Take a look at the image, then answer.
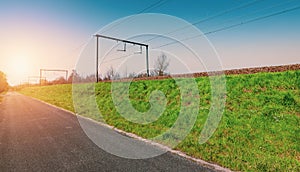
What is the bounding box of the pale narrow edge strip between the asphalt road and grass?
[15,92,231,172]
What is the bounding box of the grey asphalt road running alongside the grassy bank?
[0,92,211,172]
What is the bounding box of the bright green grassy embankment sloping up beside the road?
[20,70,300,171]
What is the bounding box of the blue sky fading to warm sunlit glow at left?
[0,0,300,85]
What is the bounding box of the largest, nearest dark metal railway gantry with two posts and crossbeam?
[94,34,150,82]
